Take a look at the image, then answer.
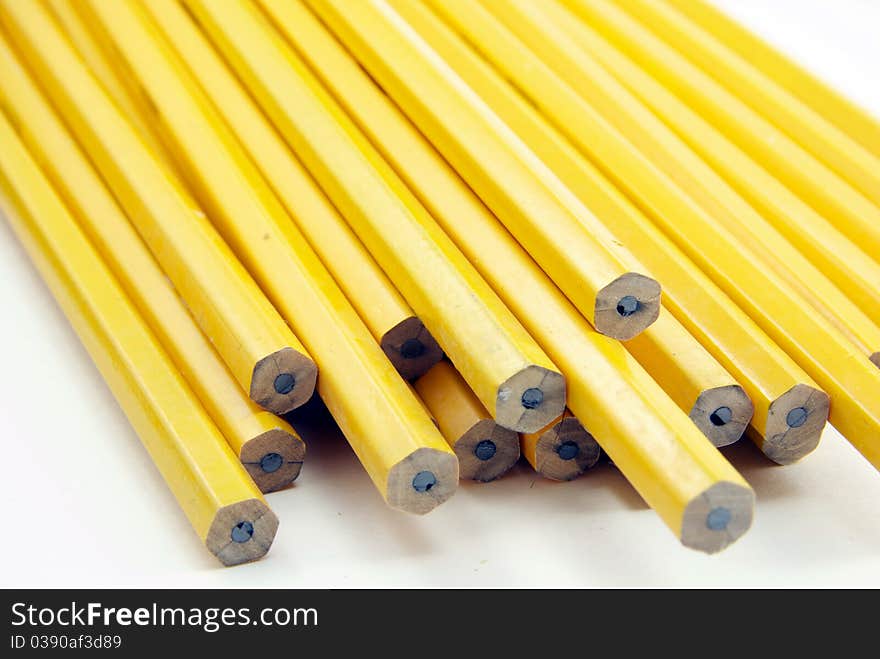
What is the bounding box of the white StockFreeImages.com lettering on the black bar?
[12,602,318,633]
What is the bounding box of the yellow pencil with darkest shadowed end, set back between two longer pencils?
[142,0,443,380]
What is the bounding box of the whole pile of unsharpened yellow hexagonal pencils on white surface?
[0,0,880,565]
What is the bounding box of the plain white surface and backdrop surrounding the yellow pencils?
[0,0,880,587]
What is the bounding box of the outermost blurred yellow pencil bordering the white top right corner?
[671,0,880,158]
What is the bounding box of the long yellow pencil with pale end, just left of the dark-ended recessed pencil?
[62,1,458,514]
